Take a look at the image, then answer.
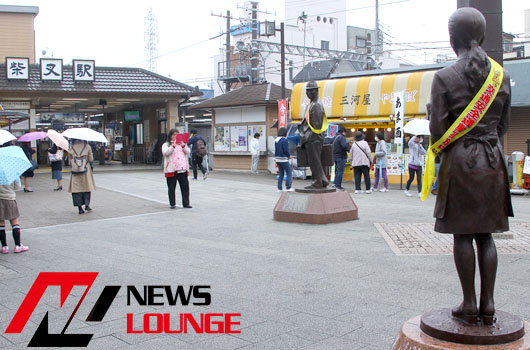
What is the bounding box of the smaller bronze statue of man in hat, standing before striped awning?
[298,81,329,189]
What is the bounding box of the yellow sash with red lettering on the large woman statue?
[421,57,504,201]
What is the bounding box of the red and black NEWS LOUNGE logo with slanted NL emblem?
[5,272,241,347]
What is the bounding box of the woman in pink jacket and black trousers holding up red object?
[162,129,191,209]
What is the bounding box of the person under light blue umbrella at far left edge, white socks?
[0,142,31,254]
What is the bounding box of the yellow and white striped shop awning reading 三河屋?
[291,70,436,120]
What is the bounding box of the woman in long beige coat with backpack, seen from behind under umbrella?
[68,140,96,214]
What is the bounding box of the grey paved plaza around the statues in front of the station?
[0,169,530,350]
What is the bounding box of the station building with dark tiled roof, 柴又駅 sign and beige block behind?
[0,5,201,163]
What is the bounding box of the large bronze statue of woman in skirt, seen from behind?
[430,7,513,325]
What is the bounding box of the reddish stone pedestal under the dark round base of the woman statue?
[391,316,530,350]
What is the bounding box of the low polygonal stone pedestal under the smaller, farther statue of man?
[274,189,359,224]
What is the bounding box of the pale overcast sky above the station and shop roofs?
[2,0,530,88]
